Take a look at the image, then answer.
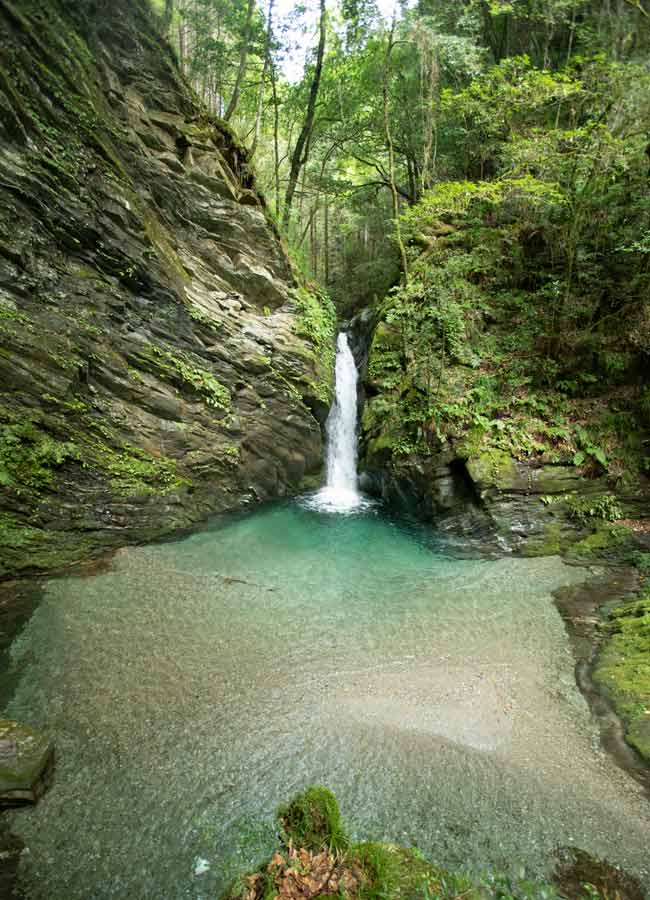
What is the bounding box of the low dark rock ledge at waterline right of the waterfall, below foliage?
[361,450,650,561]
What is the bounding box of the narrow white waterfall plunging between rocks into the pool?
[312,331,362,511]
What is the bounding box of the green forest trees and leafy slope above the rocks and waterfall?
[153,0,650,477]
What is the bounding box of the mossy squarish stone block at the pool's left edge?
[0,719,54,806]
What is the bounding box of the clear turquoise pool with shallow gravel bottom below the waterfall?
[7,503,650,900]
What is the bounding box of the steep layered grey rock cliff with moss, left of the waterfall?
[0,0,333,576]
